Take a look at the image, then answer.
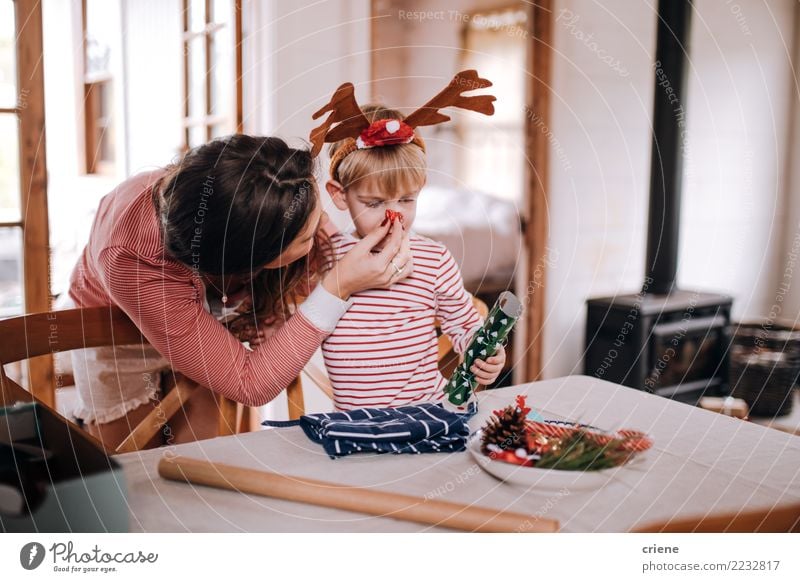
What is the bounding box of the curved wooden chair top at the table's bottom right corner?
[634,504,800,533]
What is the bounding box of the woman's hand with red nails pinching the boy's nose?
[322,222,414,300]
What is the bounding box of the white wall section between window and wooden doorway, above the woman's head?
[244,0,370,143]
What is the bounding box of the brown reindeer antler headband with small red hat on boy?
[310,69,496,178]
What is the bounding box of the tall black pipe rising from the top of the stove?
[642,0,692,295]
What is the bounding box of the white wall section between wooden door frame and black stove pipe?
[543,0,656,377]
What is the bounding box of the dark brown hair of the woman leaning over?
[153,134,324,315]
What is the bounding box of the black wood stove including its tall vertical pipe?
[584,0,733,404]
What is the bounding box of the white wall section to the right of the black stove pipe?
[679,0,796,318]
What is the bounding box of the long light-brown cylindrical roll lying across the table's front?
[158,457,558,532]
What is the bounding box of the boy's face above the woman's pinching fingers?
[327,181,421,237]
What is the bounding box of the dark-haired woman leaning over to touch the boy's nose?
[69,135,413,447]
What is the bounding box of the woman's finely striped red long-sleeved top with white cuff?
[69,170,350,406]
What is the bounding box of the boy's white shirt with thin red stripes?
[322,233,481,410]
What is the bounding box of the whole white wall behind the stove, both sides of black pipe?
[544,0,794,377]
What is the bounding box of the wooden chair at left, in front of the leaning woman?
[0,307,238,454]
